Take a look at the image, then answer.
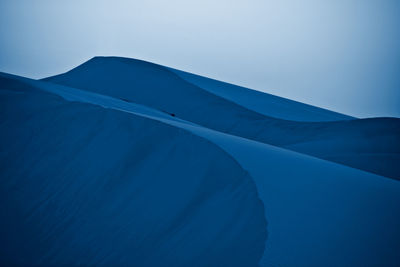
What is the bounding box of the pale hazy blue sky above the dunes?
[0,0,400,117]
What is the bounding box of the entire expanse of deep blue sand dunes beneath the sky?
[0,57,400,266]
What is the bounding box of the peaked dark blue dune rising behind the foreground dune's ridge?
[45,57,400,179]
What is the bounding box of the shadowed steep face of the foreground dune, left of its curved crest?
[0,78,267,266]
